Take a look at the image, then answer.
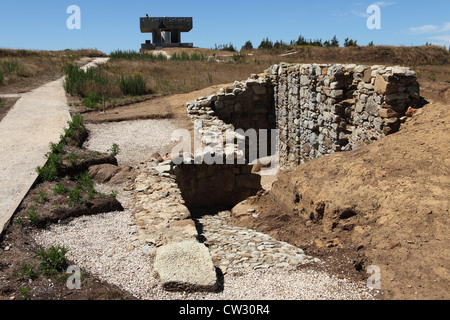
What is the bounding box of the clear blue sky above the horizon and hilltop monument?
[0,0,450,53]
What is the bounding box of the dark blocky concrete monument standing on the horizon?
[140,14,194,51]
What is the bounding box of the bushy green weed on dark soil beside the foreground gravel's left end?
[35,245,69,275]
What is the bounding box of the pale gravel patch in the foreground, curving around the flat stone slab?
[35,185,373,300]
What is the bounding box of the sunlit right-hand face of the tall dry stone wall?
[267,64,420,165]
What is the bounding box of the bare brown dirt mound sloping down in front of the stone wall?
[234,91,450,299]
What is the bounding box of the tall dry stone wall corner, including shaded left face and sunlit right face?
[187,63,420,166]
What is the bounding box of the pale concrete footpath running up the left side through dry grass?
[0,58,107,234]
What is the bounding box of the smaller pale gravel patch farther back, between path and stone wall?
[84,119,179,166]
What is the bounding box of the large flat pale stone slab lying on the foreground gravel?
[153,240,218,292]
